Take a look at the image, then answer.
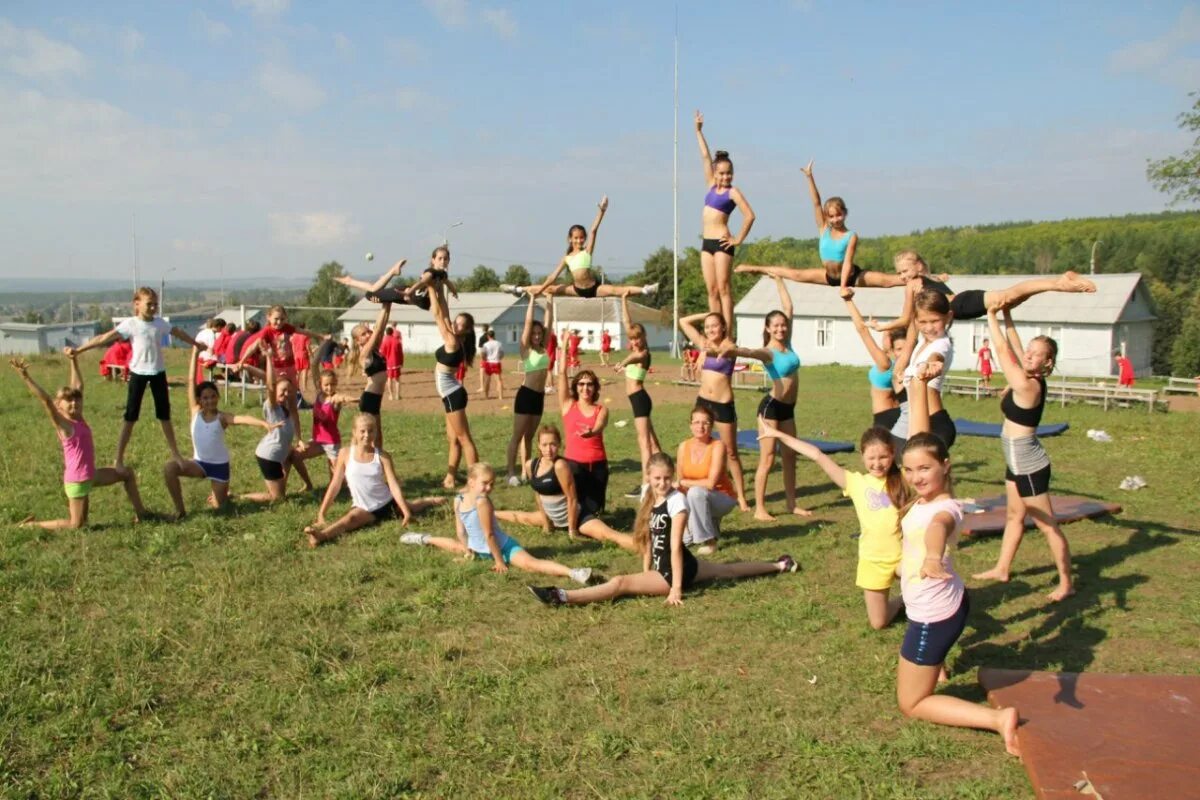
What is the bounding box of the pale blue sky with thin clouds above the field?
[0,0,1200,287]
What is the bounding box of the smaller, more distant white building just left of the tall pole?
[337,291,671,354]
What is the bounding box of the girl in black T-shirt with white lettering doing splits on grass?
[529,452,798,606]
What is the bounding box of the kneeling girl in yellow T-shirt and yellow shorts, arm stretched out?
[758,422,908,631]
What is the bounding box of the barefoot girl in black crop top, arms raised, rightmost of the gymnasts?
[974,311,1075,601]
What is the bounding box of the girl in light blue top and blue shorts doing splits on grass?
[400,462,592,585]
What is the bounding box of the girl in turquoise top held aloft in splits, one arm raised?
[737,161,905,297]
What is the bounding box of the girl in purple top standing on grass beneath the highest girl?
[679,312,750,511]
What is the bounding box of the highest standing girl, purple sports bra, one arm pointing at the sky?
[696,110,754,328]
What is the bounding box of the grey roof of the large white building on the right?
[733,272,1154,325]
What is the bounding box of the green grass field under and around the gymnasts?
[0,353,1200,798]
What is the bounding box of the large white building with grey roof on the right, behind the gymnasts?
[733,272,1156,378]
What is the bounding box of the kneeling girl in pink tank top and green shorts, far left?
[8,353,146,530]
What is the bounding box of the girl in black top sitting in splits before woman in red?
[496,425,636,552]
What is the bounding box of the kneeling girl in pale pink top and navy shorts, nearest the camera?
[896,362,1020,756]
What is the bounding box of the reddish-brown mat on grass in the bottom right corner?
[979,667,1200,800]
